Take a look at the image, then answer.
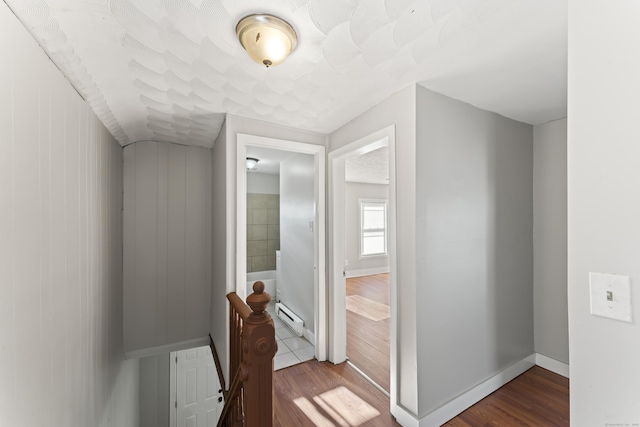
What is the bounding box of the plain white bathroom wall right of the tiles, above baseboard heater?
[277,154,315,333]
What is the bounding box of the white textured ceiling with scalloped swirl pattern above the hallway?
[6,0,567,147]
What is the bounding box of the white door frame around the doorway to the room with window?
[328,125,398,408]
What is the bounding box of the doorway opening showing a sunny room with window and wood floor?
[343,145,391,394]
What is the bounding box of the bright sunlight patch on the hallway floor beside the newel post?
[294,386,380,427]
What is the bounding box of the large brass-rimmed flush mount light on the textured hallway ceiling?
[236,14,298,68]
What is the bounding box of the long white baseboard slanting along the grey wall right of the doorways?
[420,354,536,427]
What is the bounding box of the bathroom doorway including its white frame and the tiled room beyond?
[236,134,326,369]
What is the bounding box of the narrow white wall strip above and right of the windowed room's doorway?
[329,85,418,416]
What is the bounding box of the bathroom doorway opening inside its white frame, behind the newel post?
[246,145,315,370]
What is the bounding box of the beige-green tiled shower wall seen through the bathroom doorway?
[247,193,280,273]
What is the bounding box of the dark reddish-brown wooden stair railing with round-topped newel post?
[210,282,278,427]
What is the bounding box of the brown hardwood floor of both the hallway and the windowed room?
[274,274,569,427]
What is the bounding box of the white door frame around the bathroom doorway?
[236,133,327,361]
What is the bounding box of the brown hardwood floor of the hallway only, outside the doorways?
[274,360,569,427]
